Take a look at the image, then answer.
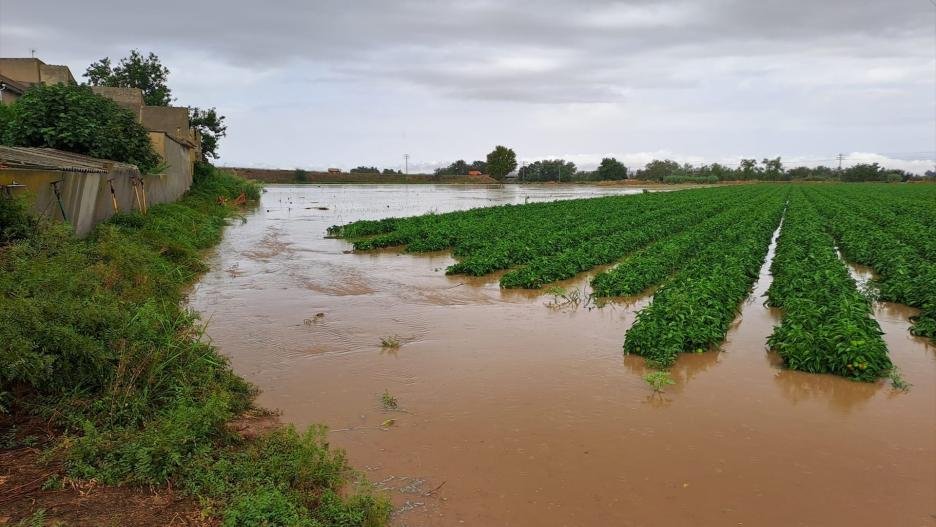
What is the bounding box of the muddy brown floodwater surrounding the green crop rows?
[191,186,936,526]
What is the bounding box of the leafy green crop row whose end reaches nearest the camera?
[767,189,891,381]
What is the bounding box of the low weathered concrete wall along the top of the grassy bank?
[0,161,192,237]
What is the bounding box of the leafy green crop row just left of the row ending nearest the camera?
[624,192,785,367]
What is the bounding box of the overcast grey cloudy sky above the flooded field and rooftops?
[0,0,936,172]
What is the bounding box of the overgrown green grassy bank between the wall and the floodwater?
[0,165,389,526]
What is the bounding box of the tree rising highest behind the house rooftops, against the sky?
[84,49,172,106]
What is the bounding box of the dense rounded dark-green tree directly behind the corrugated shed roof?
[4,84,160,173]
